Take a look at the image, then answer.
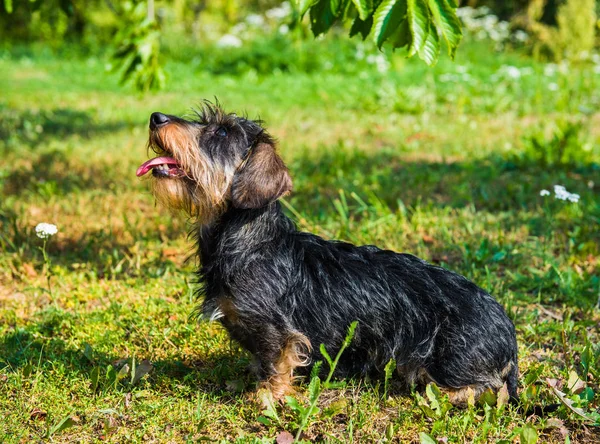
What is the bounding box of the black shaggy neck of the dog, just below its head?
[196,202,296,266]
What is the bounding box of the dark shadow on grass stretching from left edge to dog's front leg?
[0,307,254,396]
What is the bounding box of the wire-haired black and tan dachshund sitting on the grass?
[137,103,518,404]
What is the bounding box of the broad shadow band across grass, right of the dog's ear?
[290,149,598,219]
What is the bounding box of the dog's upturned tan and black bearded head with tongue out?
[137,102,292,223]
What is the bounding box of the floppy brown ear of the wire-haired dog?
[231,141,292,209]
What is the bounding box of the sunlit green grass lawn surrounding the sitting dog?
[0,35,600,443]
